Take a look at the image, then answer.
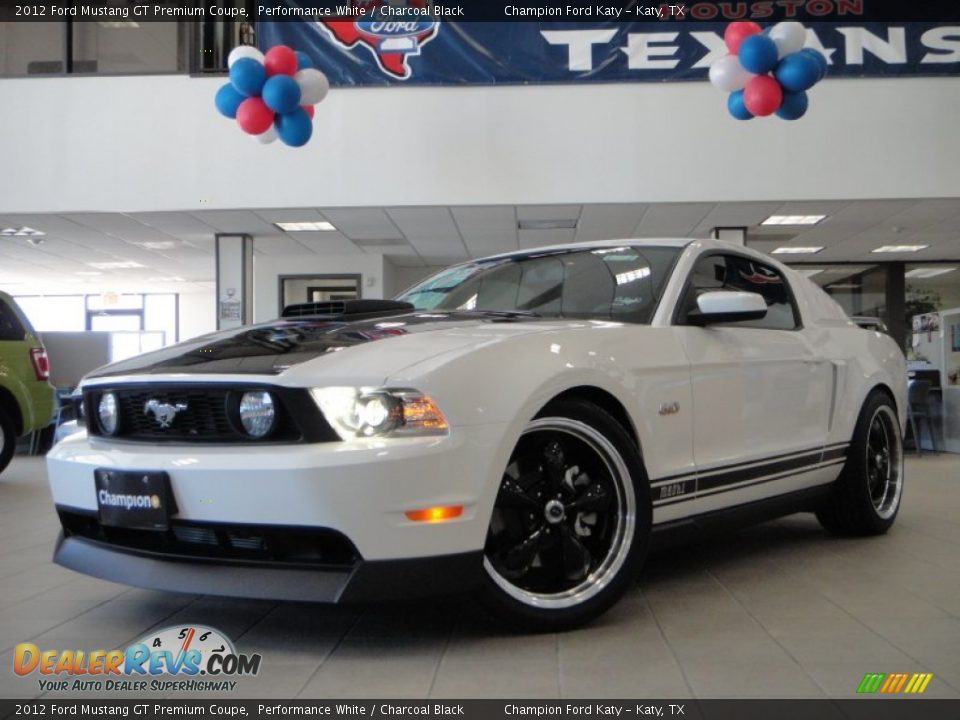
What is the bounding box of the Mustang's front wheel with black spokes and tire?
[479,401,653,632]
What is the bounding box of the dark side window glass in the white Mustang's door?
[684,255,799,330]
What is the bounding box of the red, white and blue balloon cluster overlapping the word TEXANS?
[710,21,827,120]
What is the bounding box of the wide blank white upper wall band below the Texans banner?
[0,76,960,215]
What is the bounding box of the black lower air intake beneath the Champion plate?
[59,510,361,567]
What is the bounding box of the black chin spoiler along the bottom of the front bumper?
[53,533,483,603]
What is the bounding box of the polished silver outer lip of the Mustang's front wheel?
[483,417,637,610]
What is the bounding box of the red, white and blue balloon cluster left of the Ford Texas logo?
[214,45,330,147]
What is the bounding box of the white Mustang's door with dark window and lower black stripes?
[674,251,833,513]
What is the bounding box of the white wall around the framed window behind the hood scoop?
[253,255,386,322]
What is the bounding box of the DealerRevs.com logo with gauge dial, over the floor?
[13,625,262,692]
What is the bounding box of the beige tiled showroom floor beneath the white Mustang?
[0,455,960,698]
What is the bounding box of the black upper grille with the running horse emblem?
[84,383,339,443]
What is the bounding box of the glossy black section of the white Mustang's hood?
[87,312,556,379]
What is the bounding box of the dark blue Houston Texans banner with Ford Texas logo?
[258,18,960,86]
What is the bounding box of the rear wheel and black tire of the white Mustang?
[817,391,903,537]
